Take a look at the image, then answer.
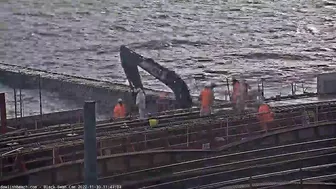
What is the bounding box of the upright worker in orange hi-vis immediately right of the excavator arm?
[200,83,215,116]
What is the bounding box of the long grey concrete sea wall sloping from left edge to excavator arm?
[0,64,202,115]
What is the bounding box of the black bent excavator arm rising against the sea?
[120,45,192,108]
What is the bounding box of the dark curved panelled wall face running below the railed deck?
[0,122,336,185]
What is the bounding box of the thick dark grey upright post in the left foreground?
[84,101,97,186]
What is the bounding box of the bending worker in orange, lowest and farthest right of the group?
[258,102,274,133]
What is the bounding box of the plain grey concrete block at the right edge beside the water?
[317,73,336,95]
